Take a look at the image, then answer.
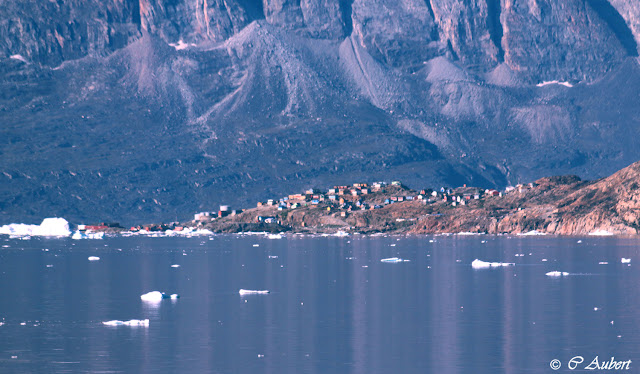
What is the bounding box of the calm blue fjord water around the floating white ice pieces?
[0,235,640,373]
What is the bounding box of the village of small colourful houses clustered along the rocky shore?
[78,181,536,233]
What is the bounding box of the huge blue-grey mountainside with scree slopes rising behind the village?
[0,0,640,223]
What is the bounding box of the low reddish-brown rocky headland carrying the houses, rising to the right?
[166,162,640,235]
